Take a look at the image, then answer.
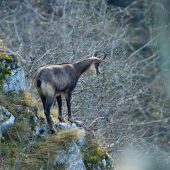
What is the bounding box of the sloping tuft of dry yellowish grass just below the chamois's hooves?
[19,129,83,170]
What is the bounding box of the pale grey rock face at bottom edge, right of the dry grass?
[53,141,86,170]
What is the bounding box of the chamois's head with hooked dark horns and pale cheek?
[88,51,106,75]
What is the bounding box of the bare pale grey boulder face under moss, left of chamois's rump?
[3,68,25,93]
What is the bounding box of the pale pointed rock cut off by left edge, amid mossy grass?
[0,106,15,137]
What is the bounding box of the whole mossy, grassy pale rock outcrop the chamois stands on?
[0,48,111,170]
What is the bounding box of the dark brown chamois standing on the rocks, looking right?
[34,51,106,133]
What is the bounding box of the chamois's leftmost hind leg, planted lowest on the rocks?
[44,96,55,133]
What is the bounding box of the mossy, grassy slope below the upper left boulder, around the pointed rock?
[0,91,37,169]
